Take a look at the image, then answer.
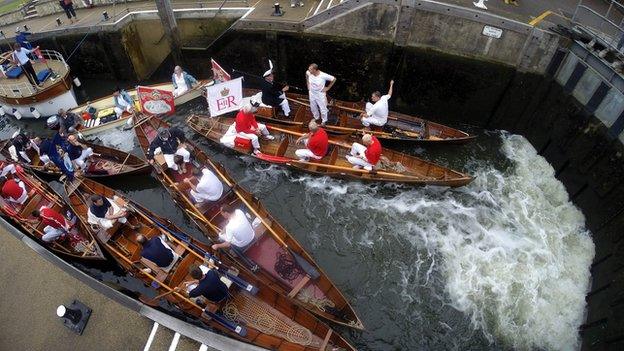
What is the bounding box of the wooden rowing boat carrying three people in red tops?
[187,115,472,187]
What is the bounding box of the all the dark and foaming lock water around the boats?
[0,97,594,350]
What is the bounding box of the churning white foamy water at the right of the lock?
[290,134,594,350]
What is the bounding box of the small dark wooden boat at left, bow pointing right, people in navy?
[0,140,150,178]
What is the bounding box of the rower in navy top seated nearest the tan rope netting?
[175,260,228,303]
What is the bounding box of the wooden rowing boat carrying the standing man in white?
[244,89,476,144]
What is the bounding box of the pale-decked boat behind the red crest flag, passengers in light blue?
[70,80,213,136]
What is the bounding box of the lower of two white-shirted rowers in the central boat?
[212,205,255,250]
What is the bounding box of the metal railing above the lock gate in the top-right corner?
[572,0,624,53]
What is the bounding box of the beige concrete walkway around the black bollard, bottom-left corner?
[0,227,205,351]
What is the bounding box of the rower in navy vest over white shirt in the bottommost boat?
[87,194,138,229]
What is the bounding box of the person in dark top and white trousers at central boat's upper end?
[147,127,191,171]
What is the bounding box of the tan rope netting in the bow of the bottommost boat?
[222,293,320,347]
